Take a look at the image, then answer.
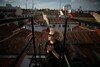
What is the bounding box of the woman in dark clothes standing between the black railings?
[45,28,62,67]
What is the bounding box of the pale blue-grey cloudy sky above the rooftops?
[0,0,100,10]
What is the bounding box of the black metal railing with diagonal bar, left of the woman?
[0,17,36,67]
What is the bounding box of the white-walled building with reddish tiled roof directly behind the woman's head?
[43,10,77,31]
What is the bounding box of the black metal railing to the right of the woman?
[63,18,100,67]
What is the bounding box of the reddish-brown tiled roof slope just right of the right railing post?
[66,30,100,44]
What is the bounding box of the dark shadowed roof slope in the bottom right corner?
[75,45,100,64]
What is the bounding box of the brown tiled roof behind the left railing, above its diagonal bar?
[0,29,31,55]
